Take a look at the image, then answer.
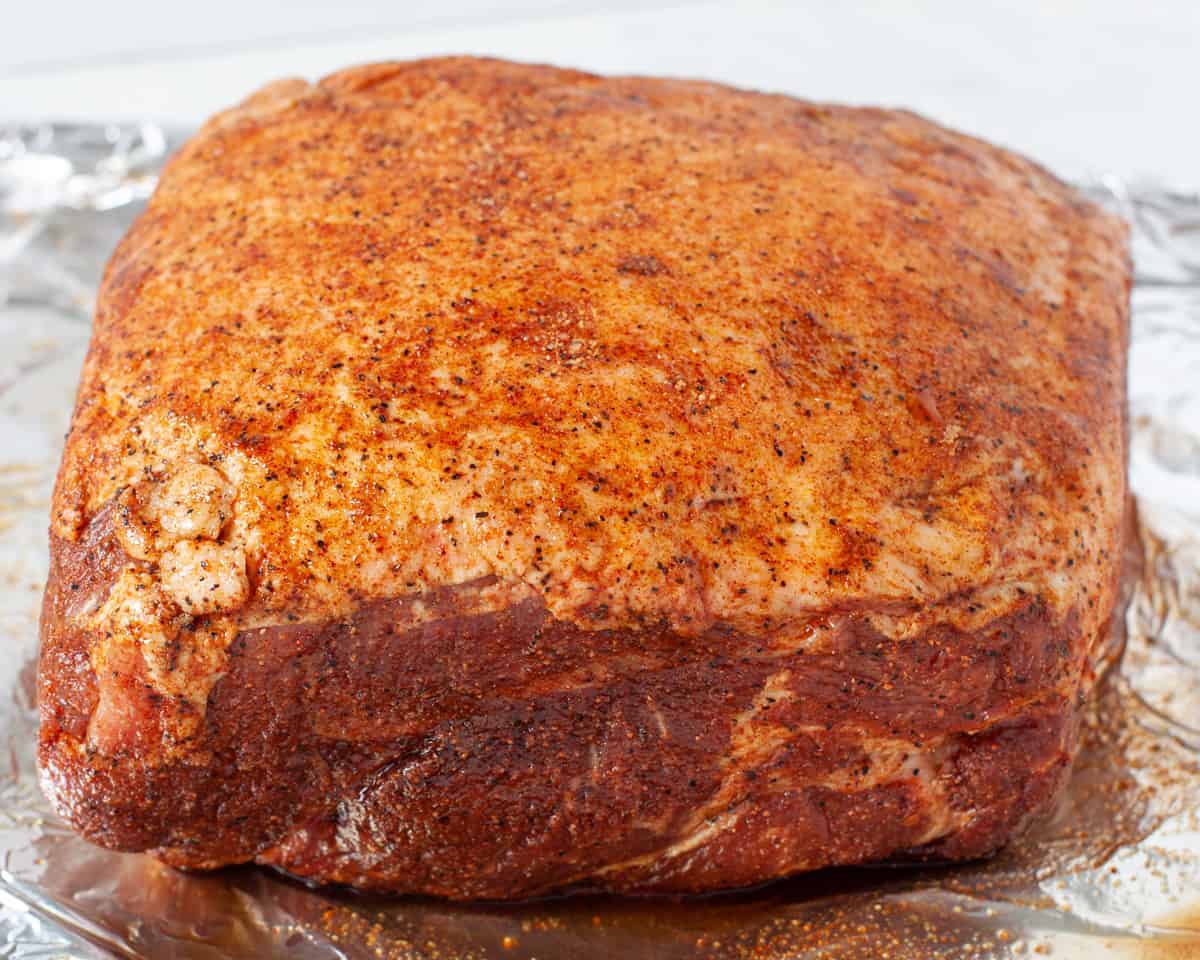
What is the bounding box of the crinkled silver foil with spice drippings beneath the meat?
[0,126,1200,960]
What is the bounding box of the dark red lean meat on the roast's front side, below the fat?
[40,501,1091,898]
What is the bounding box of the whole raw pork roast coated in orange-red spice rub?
[32,59,1130,898]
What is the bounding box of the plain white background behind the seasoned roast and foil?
[0,0,1200,187]
